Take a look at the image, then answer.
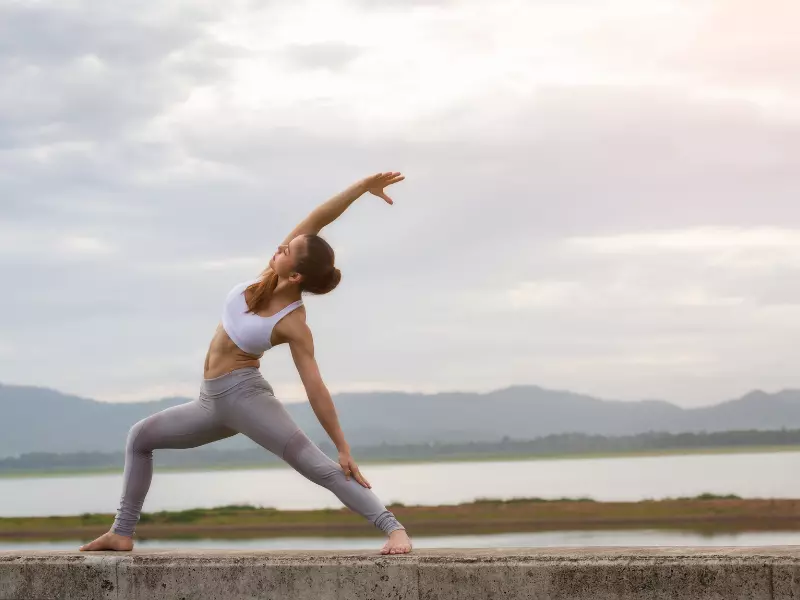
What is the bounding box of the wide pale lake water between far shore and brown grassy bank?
[0,452,800,516]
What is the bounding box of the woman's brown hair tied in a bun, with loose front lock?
[247,234,342,313]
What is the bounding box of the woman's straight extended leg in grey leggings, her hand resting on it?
[220,379,404,534]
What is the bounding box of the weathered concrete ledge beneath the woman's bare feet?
[0,546,800,600]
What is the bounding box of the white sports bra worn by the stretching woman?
[222,279,303,355]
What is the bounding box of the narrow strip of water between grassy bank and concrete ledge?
[0,530,800,551]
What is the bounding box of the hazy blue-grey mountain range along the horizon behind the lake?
[0,384,800,458]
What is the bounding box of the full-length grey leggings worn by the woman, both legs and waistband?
[111,367,404,536]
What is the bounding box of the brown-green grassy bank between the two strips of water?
[0,495,800,540]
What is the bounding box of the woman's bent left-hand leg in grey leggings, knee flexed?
[111,398,236,536]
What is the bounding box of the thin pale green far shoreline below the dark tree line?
[0,445,800,479]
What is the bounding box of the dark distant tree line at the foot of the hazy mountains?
[0,429,800,473]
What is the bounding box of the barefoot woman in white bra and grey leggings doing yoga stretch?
[80,173,411,554]
